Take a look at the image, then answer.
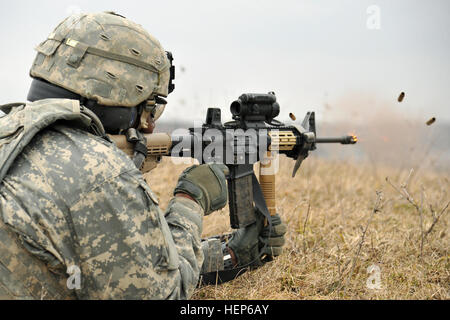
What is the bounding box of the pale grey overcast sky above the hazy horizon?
[0,0,450,121]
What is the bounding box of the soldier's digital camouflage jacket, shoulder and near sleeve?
[0,100,204,299]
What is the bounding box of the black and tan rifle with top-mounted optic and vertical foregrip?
[111,92,357,229]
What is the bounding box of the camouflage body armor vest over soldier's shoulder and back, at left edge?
[0,99,105,300]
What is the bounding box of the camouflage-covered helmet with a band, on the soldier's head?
[30,13,170,107]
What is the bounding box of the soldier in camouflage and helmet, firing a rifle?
[0,12,286,299]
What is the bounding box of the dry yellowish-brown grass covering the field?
[149,157,450,300]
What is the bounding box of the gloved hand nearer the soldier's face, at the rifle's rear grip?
[174,164,229,215]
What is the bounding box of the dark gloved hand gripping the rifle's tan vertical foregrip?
[228,214,287,267]
